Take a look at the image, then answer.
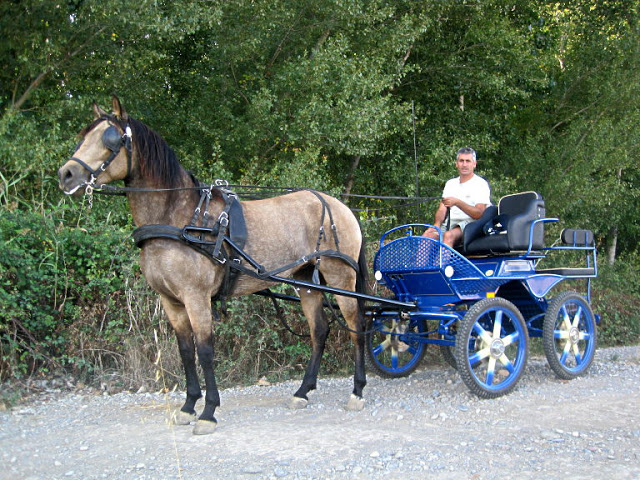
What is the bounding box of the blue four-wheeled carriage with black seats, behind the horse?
[367,192,599,398]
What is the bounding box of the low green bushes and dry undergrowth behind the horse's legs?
[0,210,351,388]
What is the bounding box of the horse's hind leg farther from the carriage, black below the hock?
[290,290,329,409]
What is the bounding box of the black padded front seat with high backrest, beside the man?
[463,192,545,255]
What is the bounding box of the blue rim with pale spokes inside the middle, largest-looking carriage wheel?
[468,307,527,393]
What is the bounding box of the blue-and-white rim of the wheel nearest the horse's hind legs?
[369,318,425,373]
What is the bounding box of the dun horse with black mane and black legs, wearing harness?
[58,96,366,435]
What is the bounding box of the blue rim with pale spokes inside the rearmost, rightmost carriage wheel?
[553,298,595,373]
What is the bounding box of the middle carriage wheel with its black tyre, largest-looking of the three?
[455,297,529,398]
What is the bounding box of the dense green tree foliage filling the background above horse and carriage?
[0,0,640,384]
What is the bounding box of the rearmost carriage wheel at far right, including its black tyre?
[542,292,597,380]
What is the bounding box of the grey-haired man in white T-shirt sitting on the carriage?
[423,147,491,247]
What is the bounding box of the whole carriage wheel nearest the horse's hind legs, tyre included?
[365,316,427,378]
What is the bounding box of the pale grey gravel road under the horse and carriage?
[0,347,640,480]
